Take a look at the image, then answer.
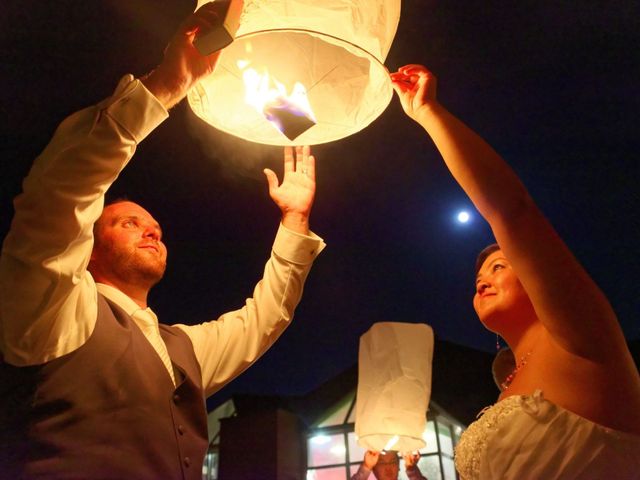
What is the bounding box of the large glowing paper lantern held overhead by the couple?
[188,0,400,145]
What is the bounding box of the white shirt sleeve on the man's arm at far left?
[0,75,168,366]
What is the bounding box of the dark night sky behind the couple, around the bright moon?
[0,0,640,405]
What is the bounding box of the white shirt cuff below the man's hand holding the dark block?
[98,74,169,143]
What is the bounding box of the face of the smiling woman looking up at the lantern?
[473,250,533,332]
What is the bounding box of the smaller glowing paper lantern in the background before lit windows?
[355,322,433,452]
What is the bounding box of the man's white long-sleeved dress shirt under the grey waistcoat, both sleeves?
[0,75,324,394]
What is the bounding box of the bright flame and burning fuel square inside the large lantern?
[238,60,316,140]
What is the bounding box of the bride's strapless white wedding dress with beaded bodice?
[455,390,640,480]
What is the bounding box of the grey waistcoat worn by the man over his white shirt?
[0,295,208,480]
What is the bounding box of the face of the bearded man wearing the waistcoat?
[89,202,167,288]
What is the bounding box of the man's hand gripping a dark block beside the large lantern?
[142,2,225,109]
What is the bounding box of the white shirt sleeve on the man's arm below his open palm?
[175,224,325,396]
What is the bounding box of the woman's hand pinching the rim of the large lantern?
[391,65,437,123]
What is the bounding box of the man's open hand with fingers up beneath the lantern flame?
[264,147,316,235]
